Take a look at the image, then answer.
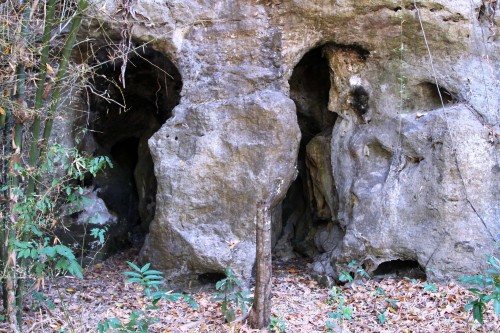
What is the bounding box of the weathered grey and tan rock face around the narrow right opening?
[80,0,500,283]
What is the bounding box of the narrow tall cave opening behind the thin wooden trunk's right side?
[275,47,338,257]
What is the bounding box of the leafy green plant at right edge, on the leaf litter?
[458,256,500,324]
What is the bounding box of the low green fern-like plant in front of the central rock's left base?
[97,262,198,333]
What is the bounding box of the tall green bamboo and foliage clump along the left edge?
[0,0,94,332]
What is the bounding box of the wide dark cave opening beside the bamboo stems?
[86,47,182,248]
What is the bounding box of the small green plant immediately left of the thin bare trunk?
[214,267,253,323]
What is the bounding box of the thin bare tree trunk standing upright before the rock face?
[248,201,272,329]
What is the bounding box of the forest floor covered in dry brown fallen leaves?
[0,250,500,333]
